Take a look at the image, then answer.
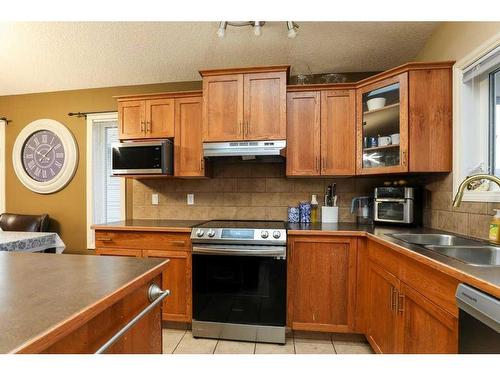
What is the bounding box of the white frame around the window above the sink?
[453,33,500,202]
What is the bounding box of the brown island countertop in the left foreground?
[0,252,168,353]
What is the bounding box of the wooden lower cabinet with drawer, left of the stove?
[96,230,192,323]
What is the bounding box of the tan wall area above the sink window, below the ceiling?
[415,22,500,61]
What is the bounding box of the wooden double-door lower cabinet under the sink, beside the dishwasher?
[367,263,458,354]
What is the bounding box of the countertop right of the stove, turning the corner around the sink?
[287,223,500,298]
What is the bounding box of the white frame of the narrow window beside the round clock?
[87,112,126,249]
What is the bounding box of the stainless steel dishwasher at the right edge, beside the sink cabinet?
[455,284,500,354]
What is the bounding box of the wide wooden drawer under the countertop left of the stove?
[95,231,191,251]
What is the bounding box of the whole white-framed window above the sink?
[453,36,500,202]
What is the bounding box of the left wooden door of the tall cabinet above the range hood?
[203,74,243,142]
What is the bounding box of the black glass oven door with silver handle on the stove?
[193,245,286,327]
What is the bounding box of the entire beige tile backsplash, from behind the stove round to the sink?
[130,162,494,238]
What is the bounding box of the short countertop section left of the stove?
[92,219,208,233]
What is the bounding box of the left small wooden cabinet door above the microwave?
[118,100,146,139]
